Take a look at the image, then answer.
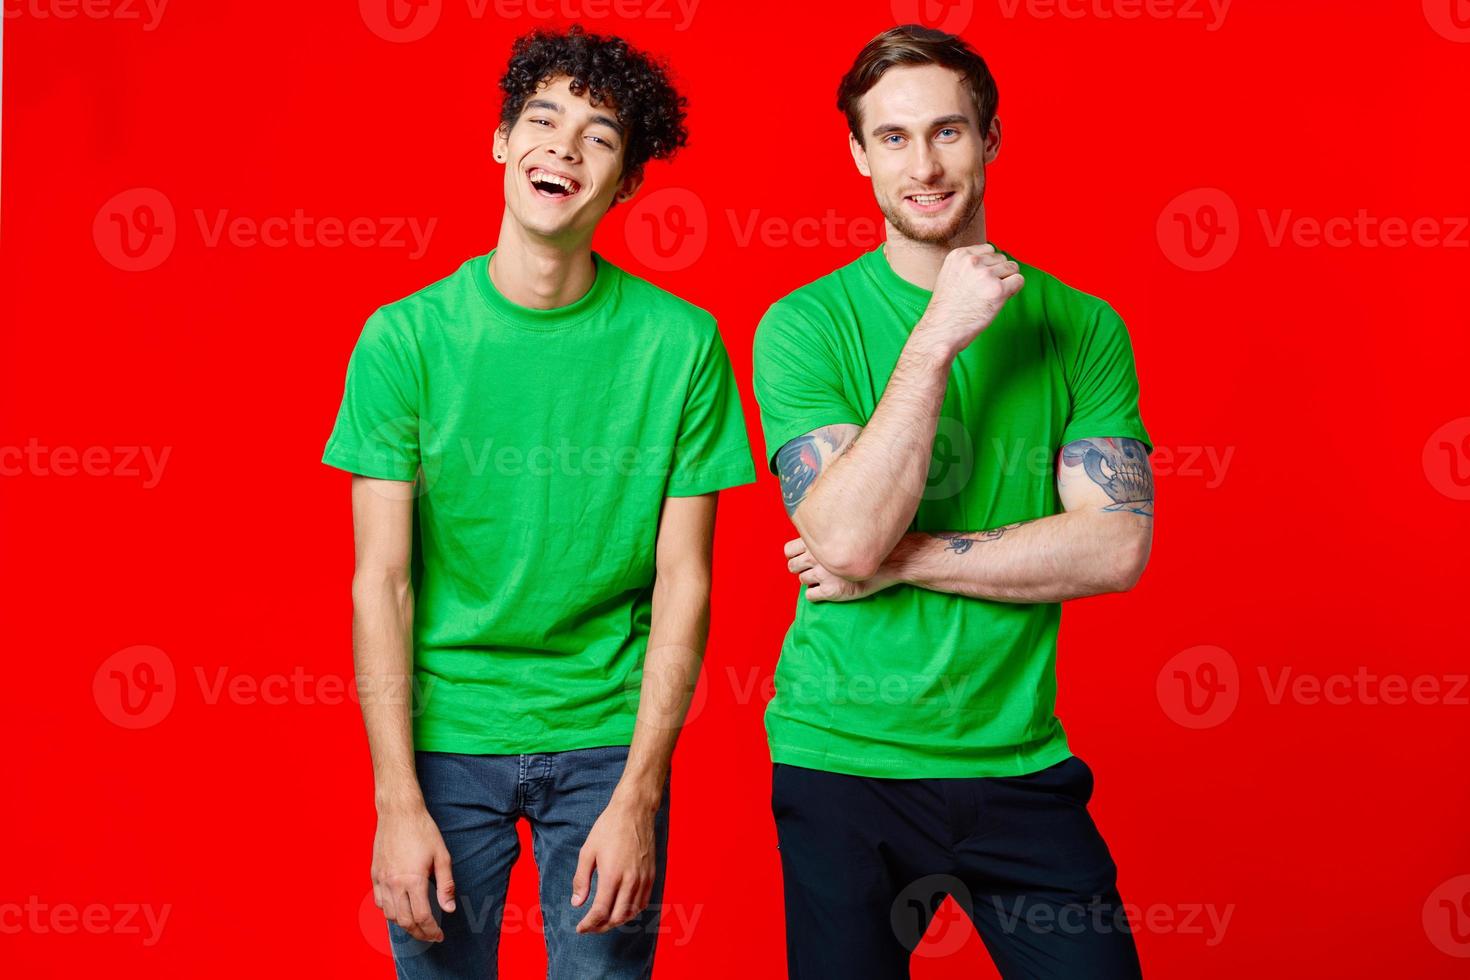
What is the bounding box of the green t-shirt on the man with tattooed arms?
[754,247,1152,777]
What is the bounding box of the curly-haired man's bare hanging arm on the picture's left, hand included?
[353,476,454,942]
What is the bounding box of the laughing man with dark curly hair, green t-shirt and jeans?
[323,28,756,980]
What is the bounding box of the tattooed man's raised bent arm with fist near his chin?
[776,245,1023,580]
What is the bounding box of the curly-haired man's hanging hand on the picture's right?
[572,793,657,933]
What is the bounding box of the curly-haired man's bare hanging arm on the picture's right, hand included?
[572,494,719,933]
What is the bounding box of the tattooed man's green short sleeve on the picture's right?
[1061,303,1154,453]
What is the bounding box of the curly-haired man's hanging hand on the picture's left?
[372,805,454,943]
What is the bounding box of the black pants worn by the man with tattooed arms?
[772,757,1141,980]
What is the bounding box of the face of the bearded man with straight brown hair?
[848,65,1001,244]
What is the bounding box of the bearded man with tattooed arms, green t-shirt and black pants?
[754,26,1154,980]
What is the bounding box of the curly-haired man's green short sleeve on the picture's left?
[322,310,419,480]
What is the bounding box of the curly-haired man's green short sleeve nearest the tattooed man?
[664,326,756,497]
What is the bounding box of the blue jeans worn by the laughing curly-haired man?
[388,745,669,980]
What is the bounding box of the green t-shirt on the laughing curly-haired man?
[322,253,756,754]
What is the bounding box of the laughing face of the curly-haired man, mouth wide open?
[495,75,641,244]
